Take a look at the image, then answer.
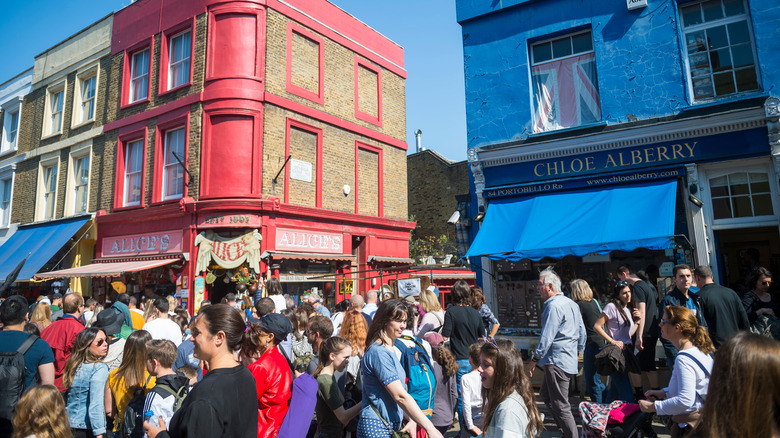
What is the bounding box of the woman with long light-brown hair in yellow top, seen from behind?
[105,330,156,436]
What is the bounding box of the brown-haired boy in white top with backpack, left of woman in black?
[144,339,188,428]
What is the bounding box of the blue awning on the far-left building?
[0,215,91,283]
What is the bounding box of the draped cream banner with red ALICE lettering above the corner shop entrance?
[195,230,263,273]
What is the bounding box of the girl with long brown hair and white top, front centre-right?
[478,339,544,438]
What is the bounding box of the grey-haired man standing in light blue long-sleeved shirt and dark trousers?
[529,267,586,438]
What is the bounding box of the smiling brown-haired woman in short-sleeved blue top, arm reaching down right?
[357,299,443,438]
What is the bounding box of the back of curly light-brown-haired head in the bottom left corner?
[13,385,73,438]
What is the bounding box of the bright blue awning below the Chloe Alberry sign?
[466,180,677,261]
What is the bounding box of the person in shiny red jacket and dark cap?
[241,313,292,438]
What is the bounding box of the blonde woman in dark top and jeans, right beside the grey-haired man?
[569,279,606,403]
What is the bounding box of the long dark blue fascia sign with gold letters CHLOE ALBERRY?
[484,128,769,186]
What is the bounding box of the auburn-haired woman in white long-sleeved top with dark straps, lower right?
[639,306,715,437]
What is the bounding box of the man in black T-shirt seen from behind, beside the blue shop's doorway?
[693,265,750,348]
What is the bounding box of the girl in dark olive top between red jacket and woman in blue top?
[313,336,361,438]
